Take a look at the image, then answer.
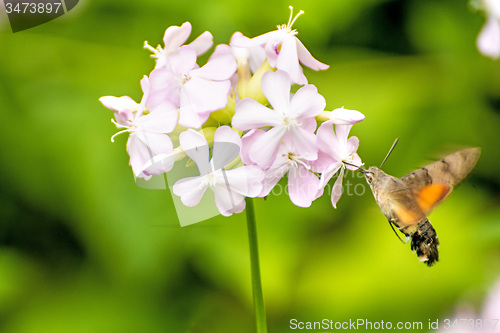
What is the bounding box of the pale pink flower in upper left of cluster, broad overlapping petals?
[149,44,236,128]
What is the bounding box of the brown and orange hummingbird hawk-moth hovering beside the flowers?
[362,140,481,266]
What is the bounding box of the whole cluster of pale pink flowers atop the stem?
[100,7,364,216]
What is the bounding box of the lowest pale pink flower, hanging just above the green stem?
[173,126,264,216]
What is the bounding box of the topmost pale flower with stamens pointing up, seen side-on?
[231,6,329,85]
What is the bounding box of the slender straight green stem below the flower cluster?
[246,198,267,333]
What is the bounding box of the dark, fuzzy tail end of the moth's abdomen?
[401,219,439,267]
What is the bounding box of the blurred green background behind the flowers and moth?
[0,0,500,333]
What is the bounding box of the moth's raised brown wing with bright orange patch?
[401,148,481,214]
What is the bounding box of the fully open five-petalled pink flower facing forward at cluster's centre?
[232,70,326,168]
